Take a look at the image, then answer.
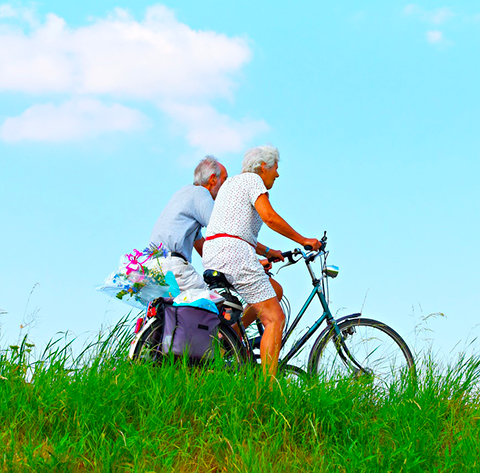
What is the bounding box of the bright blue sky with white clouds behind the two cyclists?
[0,0,480,362]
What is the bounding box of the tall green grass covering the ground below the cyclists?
[0,318,480,473]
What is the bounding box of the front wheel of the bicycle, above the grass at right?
[308,318,416,387]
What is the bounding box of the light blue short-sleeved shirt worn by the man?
[150,184,214,262]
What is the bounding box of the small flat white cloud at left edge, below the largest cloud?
[0,98,148,143]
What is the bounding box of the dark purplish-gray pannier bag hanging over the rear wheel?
[162,299,220,359]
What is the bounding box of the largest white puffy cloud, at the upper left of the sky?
[0,6,251,99]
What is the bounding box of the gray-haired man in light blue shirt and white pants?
[150,156,228,291]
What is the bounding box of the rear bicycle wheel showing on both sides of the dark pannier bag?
[132,320,247,367]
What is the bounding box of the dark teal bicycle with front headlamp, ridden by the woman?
[133,232,416,384]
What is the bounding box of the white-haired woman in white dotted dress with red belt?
[203,146,321,375]
